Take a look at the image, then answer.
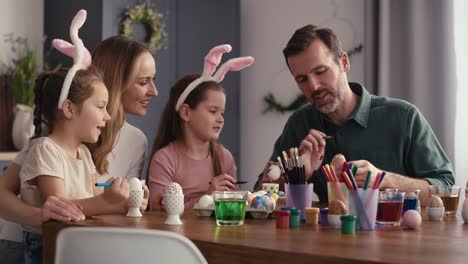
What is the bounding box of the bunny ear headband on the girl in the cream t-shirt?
[52,9,91,109]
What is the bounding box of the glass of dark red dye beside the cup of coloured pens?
[376,189,405,226]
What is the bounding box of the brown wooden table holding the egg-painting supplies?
[43,210,468,264]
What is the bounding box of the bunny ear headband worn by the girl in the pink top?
[175,44,254,111]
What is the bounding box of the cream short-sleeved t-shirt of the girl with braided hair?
[20,137,96,233]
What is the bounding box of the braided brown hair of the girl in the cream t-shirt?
[32,66,106,170]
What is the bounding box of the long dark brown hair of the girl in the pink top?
[151,74,224,176]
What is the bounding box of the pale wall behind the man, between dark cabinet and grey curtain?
[239,0,365,189]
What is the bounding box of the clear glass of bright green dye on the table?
[213,191,247,226]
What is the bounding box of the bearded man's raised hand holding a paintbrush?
[299,129,326,179]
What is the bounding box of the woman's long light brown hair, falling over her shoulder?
[88,36,150,174]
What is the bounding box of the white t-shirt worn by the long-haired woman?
[98,122,148,182]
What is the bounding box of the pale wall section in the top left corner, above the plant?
[0,0,44,71]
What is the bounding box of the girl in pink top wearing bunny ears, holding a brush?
[148,45,253,210]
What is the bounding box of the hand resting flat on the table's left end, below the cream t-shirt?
[41,195,86,222]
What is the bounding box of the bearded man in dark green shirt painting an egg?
[255,25,455,206]
